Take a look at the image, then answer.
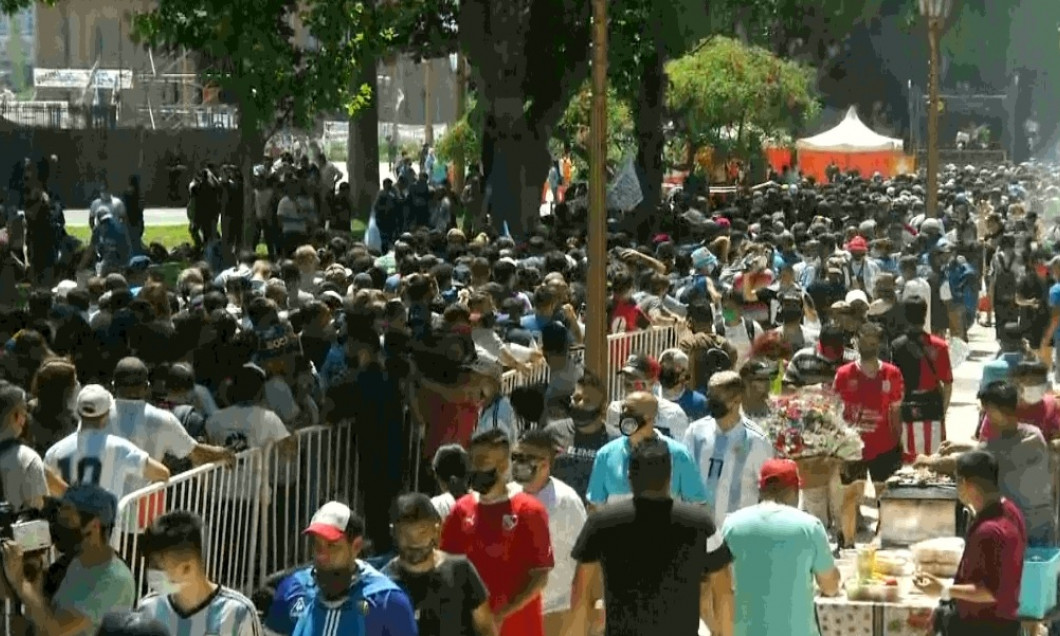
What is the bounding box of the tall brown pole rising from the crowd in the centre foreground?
[585,0,611,387]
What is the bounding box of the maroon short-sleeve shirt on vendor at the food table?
[953,499,1027,622]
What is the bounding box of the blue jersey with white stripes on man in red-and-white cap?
[292,562,419,636]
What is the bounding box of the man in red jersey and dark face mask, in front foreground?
[440,428,553,636]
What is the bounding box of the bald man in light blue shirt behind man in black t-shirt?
[586,391,706,507]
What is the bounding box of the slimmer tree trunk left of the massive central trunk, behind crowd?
[346,58,379,223]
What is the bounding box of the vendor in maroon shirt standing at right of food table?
[913,451,1027,636]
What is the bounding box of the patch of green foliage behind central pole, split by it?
[551,81,636,174]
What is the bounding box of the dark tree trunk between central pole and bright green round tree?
[633,47,666,238]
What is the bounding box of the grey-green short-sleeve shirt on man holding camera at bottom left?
[52,555,136,636]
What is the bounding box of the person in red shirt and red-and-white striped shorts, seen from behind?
[890,296,953,463]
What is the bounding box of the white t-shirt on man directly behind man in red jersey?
[534,477,587,614]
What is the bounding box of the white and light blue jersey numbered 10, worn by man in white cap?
[45,428,147,501]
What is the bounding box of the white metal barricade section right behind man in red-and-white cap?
[259,423,360,577]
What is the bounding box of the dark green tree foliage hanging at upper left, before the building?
[135,0,394,138]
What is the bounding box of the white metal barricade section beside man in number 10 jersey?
[110,448,267,594]
